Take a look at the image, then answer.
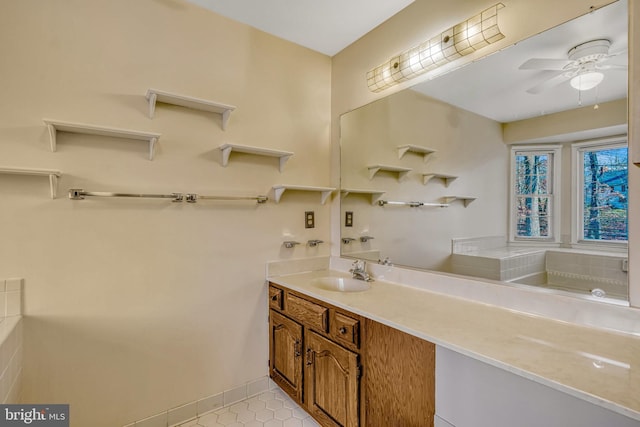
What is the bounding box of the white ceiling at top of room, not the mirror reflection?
[189,0,414,56]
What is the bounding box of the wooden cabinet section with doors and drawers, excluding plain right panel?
[269,285,363,427]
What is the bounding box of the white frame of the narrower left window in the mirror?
[509,145,562,245]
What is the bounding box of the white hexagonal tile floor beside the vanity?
[180,388,320,427]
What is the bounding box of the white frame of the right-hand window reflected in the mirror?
[571,135,629,251]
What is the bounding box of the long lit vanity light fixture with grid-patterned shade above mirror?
[367,3,505,92]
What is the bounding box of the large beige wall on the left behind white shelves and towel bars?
[0,0,331,427]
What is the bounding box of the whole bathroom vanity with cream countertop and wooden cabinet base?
[268,269,640,427]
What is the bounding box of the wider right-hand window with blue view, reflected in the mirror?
[573,141,628,244]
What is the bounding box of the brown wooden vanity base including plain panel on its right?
[269,283,435,427]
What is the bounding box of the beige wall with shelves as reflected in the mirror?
[340,91,509,272]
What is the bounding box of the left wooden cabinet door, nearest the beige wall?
[269,310,302,403]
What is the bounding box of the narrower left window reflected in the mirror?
[511,146,560,241]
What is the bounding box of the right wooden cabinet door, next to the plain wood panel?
[304,332,360,427]
